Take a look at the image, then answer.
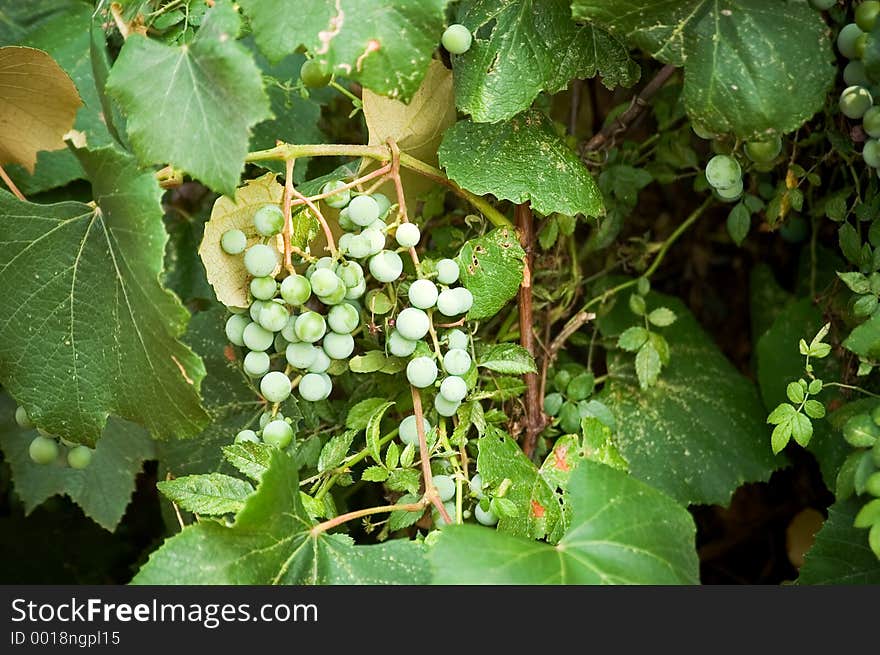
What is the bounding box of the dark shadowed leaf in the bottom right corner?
[798,498,880,585]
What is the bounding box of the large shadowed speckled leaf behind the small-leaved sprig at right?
[599,293,784,504]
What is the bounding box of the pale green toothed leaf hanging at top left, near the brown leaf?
[107,2,271,194]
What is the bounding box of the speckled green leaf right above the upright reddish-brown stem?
[440,110,603,216]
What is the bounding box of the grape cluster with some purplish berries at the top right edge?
[837,1,880,169]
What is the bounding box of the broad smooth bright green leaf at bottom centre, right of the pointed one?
[430,461,699,584]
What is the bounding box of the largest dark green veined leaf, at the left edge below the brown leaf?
[0,147,207,444]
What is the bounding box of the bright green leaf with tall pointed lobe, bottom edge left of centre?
[133,451,428,585]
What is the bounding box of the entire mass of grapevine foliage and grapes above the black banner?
[0,0,880,584]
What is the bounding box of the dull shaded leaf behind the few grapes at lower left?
[0,394,155,531]
